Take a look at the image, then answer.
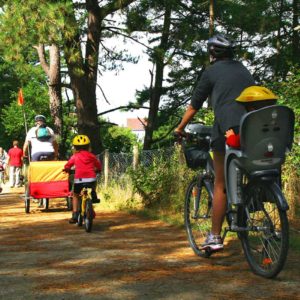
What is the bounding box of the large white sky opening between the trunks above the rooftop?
[97,40,152,126]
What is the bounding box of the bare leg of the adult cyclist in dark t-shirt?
[211,152,226,235]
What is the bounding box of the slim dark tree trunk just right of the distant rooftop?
[144,2,172,150]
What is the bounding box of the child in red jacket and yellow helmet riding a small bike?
[64,135,102,224]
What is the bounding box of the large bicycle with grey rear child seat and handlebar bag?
[183,106,294,278]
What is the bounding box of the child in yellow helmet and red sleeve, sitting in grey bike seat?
[225,85,278,148]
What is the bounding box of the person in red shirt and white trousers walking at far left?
[7,141,23,188]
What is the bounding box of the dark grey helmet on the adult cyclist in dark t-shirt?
[207,34,234,58]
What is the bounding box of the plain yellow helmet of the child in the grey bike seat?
[236,85,278,103]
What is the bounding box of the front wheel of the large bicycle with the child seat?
[184,176,212,257]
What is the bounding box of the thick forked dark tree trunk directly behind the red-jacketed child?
[64,0,136,154]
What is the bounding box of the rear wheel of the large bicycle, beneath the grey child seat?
[239,183,289,278]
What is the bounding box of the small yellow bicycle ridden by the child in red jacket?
[77,187,100,232]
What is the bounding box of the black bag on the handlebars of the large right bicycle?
[184,124,212,169]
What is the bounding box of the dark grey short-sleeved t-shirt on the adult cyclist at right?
[191,60,255,138]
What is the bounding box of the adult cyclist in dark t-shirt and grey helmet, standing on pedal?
[175,35,255,250]
